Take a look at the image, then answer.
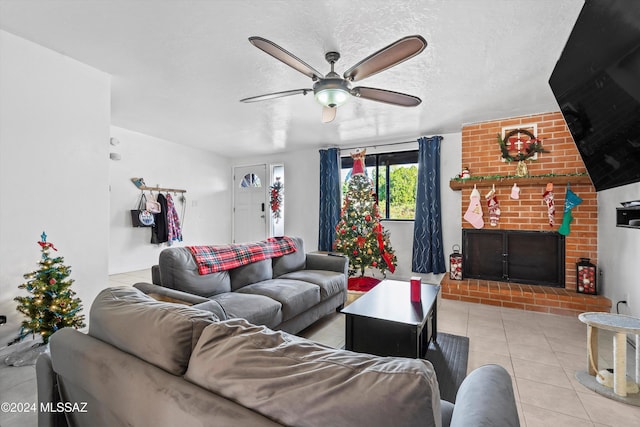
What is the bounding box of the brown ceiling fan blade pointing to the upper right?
[344,35,427,82]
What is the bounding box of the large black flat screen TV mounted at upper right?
[549,0,640,191]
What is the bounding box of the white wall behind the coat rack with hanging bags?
[109,126,231,274]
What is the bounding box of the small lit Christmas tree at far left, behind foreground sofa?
[14,232,85,344]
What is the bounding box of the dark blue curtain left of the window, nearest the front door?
[318,148,340,251]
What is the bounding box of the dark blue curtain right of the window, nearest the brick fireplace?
[411,136,446,274]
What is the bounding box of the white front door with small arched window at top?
[233,165,269,243]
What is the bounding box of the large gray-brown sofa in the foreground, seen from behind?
[36,287,519,427]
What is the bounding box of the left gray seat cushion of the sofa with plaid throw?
[212,292,282,328]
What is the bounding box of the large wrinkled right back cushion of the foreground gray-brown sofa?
[185,319,440,427]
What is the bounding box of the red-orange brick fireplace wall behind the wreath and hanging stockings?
[461,112,598,290]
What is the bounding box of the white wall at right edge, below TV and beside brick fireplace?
[598,183,640,317]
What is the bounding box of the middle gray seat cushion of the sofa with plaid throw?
[238,279,320,321]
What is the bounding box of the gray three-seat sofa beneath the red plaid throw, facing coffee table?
[134,237,349,334]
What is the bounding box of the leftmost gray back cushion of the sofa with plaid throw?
[158,248,231,297]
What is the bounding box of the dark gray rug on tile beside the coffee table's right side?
[425,332,469,403]
